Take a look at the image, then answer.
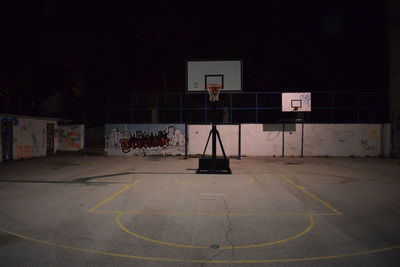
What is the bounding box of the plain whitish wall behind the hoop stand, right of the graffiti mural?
[188,124,390,157]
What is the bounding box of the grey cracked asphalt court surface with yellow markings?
[0,156,400,267]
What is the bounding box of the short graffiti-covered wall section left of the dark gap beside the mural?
[57,124,85,151]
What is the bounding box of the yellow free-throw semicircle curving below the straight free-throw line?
[115,213,314,250]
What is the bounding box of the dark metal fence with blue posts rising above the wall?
[79,92,389,124]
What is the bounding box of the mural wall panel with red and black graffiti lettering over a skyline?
[105,124,185,156]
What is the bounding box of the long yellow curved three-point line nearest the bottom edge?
[0,228,400,264]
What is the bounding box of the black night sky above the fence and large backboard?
[0,0,388,97]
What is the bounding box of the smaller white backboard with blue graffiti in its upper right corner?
[282,92,311,112]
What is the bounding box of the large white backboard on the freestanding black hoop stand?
[186,60,242,92]
